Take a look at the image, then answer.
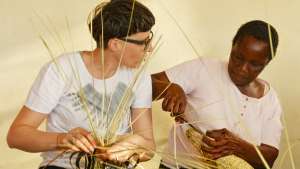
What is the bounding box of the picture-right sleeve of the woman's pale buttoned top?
[261,91,282,149]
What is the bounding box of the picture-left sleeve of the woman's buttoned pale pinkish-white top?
[165,59,203,94]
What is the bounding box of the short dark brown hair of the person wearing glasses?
[88,0,155,48]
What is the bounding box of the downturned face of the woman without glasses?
[228,36,269,87]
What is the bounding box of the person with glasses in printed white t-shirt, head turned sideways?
[7,0,155,169]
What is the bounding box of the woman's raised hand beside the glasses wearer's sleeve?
[162,83,187,117]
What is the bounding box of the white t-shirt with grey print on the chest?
[25,52,152,168]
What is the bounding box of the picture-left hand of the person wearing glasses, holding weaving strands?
[57,127,96,153]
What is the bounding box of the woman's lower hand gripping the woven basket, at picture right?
[201,128,248,159]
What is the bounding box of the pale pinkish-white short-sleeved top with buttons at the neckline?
[164,58,282,164]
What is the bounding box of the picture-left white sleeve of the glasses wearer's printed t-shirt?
[25,63,65,114]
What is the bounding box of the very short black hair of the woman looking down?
[232,20,278,60]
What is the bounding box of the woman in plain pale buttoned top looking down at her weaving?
[152,20,282,168]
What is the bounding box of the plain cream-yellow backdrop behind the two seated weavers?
[0,0,300,169]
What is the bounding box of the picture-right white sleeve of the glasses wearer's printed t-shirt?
[131,72,152,108]
